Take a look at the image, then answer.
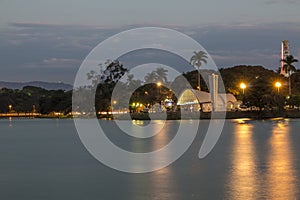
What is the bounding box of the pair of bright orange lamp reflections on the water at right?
[225,120,299,199]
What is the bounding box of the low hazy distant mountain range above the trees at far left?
[0,81,73,91]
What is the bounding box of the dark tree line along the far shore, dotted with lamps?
[0,58,300,114]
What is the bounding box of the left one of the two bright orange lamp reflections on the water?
[228,124,259,199]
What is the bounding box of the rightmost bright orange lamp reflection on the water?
[266,122,297,199]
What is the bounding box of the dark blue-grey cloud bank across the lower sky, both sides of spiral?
[0,22,300,82]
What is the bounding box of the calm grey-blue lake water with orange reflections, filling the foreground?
[0,119,300,200]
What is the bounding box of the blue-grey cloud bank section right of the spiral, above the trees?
[192,23,300,69]
